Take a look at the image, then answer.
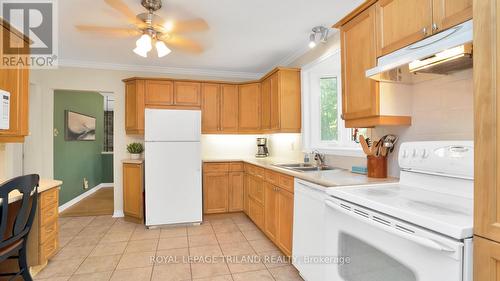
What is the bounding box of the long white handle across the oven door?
[325,200,455,253]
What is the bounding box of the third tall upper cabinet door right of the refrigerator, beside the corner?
[238,83,261,132]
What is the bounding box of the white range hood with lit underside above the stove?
[366,20,473,84]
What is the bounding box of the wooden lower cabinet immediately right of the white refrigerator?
[203,162,245,214]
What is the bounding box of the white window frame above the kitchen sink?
[301,50,364,157]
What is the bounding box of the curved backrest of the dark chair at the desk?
[0,175,40,249]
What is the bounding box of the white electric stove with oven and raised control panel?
[325,141,474,281]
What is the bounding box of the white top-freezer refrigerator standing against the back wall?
[145,109,202,226]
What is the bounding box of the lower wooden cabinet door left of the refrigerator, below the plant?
[123,163,144,220]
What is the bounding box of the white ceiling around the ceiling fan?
[58,0,363,76]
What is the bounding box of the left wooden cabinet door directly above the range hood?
[376,0,432,56]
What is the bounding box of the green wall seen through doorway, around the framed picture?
[54,90,106,205]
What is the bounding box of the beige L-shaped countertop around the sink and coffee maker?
[203,158,398,187]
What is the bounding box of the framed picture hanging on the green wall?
[64,110,96,141]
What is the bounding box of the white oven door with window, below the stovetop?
[325,197,464,281]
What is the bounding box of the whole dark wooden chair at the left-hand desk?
[0,175,40,281]
